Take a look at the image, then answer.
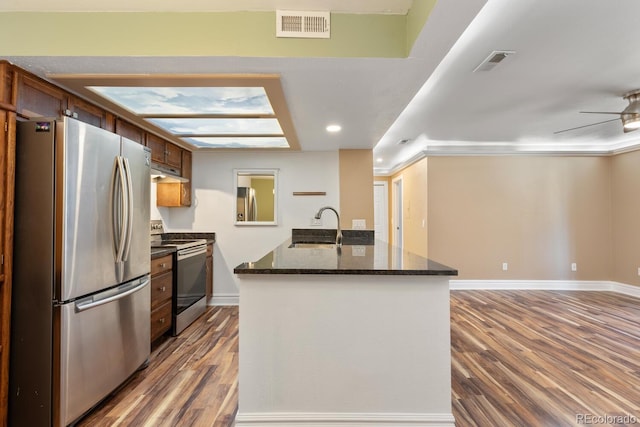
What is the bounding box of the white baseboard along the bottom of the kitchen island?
[234,412,455,427]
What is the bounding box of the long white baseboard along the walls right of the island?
[449,280,640,298]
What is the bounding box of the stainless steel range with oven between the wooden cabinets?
[151,220,207,336]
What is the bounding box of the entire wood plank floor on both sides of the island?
[79,291,640,427]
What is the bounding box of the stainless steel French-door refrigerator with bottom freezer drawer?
[9,118,150,426]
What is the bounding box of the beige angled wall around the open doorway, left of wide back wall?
[389,158,429,257]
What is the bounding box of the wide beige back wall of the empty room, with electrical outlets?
[422,156,612,280]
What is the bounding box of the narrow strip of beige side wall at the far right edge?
[611,151,640,285]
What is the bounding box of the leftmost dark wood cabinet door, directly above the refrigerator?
[17,74,67,118]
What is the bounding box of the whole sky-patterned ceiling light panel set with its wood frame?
[53,74,300,150]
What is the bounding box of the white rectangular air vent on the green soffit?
[276,10,331,39]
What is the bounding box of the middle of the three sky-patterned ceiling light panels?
[147,118,282,135]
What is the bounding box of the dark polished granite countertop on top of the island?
[234,234,458,276]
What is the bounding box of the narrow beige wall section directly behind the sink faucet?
[339,150,374,230]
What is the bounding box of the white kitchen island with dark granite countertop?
[234,240,457,427]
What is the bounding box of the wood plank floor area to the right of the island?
[451,291,640,426]
